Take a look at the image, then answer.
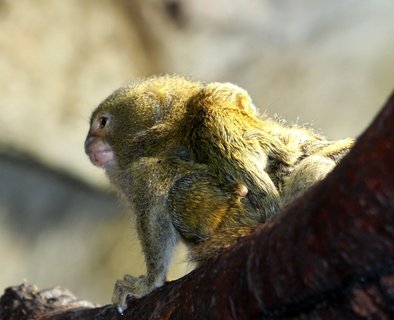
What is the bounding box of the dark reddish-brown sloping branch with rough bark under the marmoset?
[0,89,394,320]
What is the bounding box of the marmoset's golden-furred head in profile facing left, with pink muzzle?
[85,76,201,168]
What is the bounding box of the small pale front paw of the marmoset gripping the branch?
[112,274,153,314]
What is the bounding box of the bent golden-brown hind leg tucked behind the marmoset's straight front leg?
[169,171,265,264]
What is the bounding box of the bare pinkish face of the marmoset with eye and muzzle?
[85,113,115,167]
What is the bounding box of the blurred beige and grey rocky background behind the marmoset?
[0,0,394,303]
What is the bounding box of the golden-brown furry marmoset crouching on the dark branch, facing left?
[85,76,353,310]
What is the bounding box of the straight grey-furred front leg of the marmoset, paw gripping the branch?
[112,200,177,313]
